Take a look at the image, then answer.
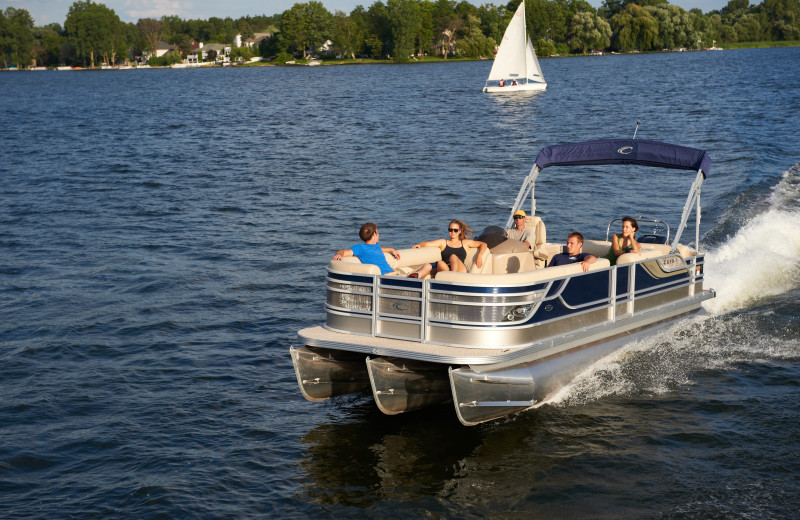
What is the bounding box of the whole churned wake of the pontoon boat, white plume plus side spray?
[542,164,800,406]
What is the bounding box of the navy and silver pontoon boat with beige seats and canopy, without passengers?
[290,139,715,425]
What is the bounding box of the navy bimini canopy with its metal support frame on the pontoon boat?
[506,139,711,249]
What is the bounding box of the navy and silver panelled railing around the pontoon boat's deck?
[326,249,704,346]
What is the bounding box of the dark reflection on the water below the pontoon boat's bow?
[302,399,482,507]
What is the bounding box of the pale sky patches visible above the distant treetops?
[0,0,728,26]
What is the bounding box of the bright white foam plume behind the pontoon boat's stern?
[703,168,800,314]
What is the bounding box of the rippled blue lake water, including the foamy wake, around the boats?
[0,48,800,519]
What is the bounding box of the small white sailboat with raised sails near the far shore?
[483,0,547,93]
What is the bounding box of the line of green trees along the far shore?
[0,0,800,68]
